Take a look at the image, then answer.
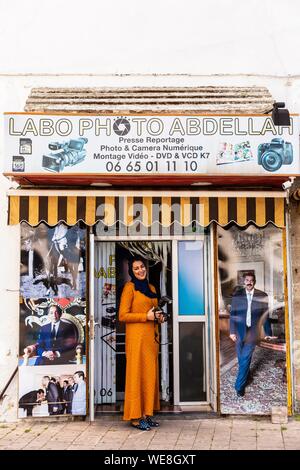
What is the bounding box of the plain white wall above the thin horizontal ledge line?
[0,0,300,76]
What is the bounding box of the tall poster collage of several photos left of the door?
[18,223,87,418]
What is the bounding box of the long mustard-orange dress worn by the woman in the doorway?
[119,282,159,421]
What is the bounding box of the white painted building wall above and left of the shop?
[0,0,300,420]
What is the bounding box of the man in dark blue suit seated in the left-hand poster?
[35,305,77,366]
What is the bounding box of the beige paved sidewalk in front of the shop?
[0,416,300,450]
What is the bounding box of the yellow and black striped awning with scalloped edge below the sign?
[8,191,285,228]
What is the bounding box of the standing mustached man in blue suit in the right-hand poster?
[230,272,272,397]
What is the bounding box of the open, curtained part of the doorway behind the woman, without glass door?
[90,239,173,419]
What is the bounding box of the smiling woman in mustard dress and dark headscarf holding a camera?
[119,258,164,431]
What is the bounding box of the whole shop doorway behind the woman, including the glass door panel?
[90,235,217,417]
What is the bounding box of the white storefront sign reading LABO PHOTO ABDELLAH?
[5,114,300,176]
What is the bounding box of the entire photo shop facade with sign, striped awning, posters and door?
[5,89,299,420]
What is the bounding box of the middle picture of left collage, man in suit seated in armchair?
[19,298,86,366]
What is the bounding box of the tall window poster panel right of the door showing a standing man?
[217,224,287,414]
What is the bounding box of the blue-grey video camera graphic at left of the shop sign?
[42,137,88,173]
